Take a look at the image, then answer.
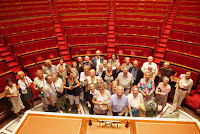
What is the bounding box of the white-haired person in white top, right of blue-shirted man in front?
[128,85,144,117]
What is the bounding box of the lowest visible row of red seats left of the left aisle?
[17,48,59,67]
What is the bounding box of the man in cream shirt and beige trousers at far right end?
[170,71,193,114]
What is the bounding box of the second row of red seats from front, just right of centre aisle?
[117,35,157,47]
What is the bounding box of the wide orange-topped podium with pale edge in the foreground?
[13,111,200,134]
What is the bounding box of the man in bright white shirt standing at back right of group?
[141,56,158,74]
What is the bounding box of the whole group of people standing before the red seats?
[5,50,193,117]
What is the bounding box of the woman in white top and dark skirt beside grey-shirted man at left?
[52,73,66,110]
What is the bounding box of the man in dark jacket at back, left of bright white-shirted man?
[129,60,143,85]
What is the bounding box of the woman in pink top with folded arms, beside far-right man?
[154,76,171,114]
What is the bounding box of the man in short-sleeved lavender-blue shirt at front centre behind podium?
[109,86,131,116]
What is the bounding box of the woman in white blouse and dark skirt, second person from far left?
[17,71,34,108]
